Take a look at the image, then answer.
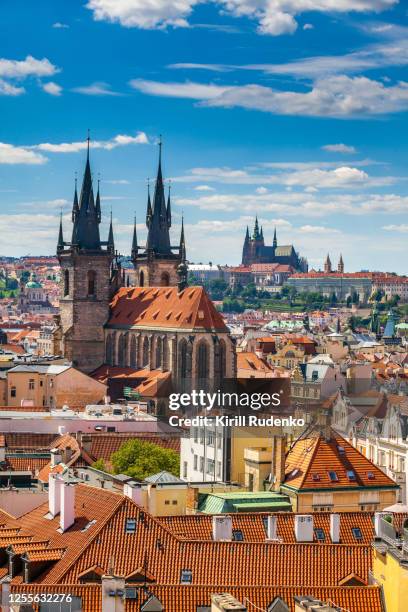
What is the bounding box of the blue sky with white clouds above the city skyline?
[0,0,408,273]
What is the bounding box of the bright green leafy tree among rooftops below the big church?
[111,439,180,480]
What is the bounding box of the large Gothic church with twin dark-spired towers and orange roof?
[54,140,236,388]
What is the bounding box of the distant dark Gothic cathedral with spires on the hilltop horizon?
[242,217,308,272]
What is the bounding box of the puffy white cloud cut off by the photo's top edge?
[86,0,398,36]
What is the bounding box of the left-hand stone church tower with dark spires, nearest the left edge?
[54,136,121,372]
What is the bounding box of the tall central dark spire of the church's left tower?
[72,132,101,251]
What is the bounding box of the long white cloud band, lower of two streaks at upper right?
[132,75,408,118]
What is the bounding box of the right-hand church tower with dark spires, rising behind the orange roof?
[132,140,185,287]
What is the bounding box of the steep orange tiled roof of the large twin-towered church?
[108,287,228,332]
